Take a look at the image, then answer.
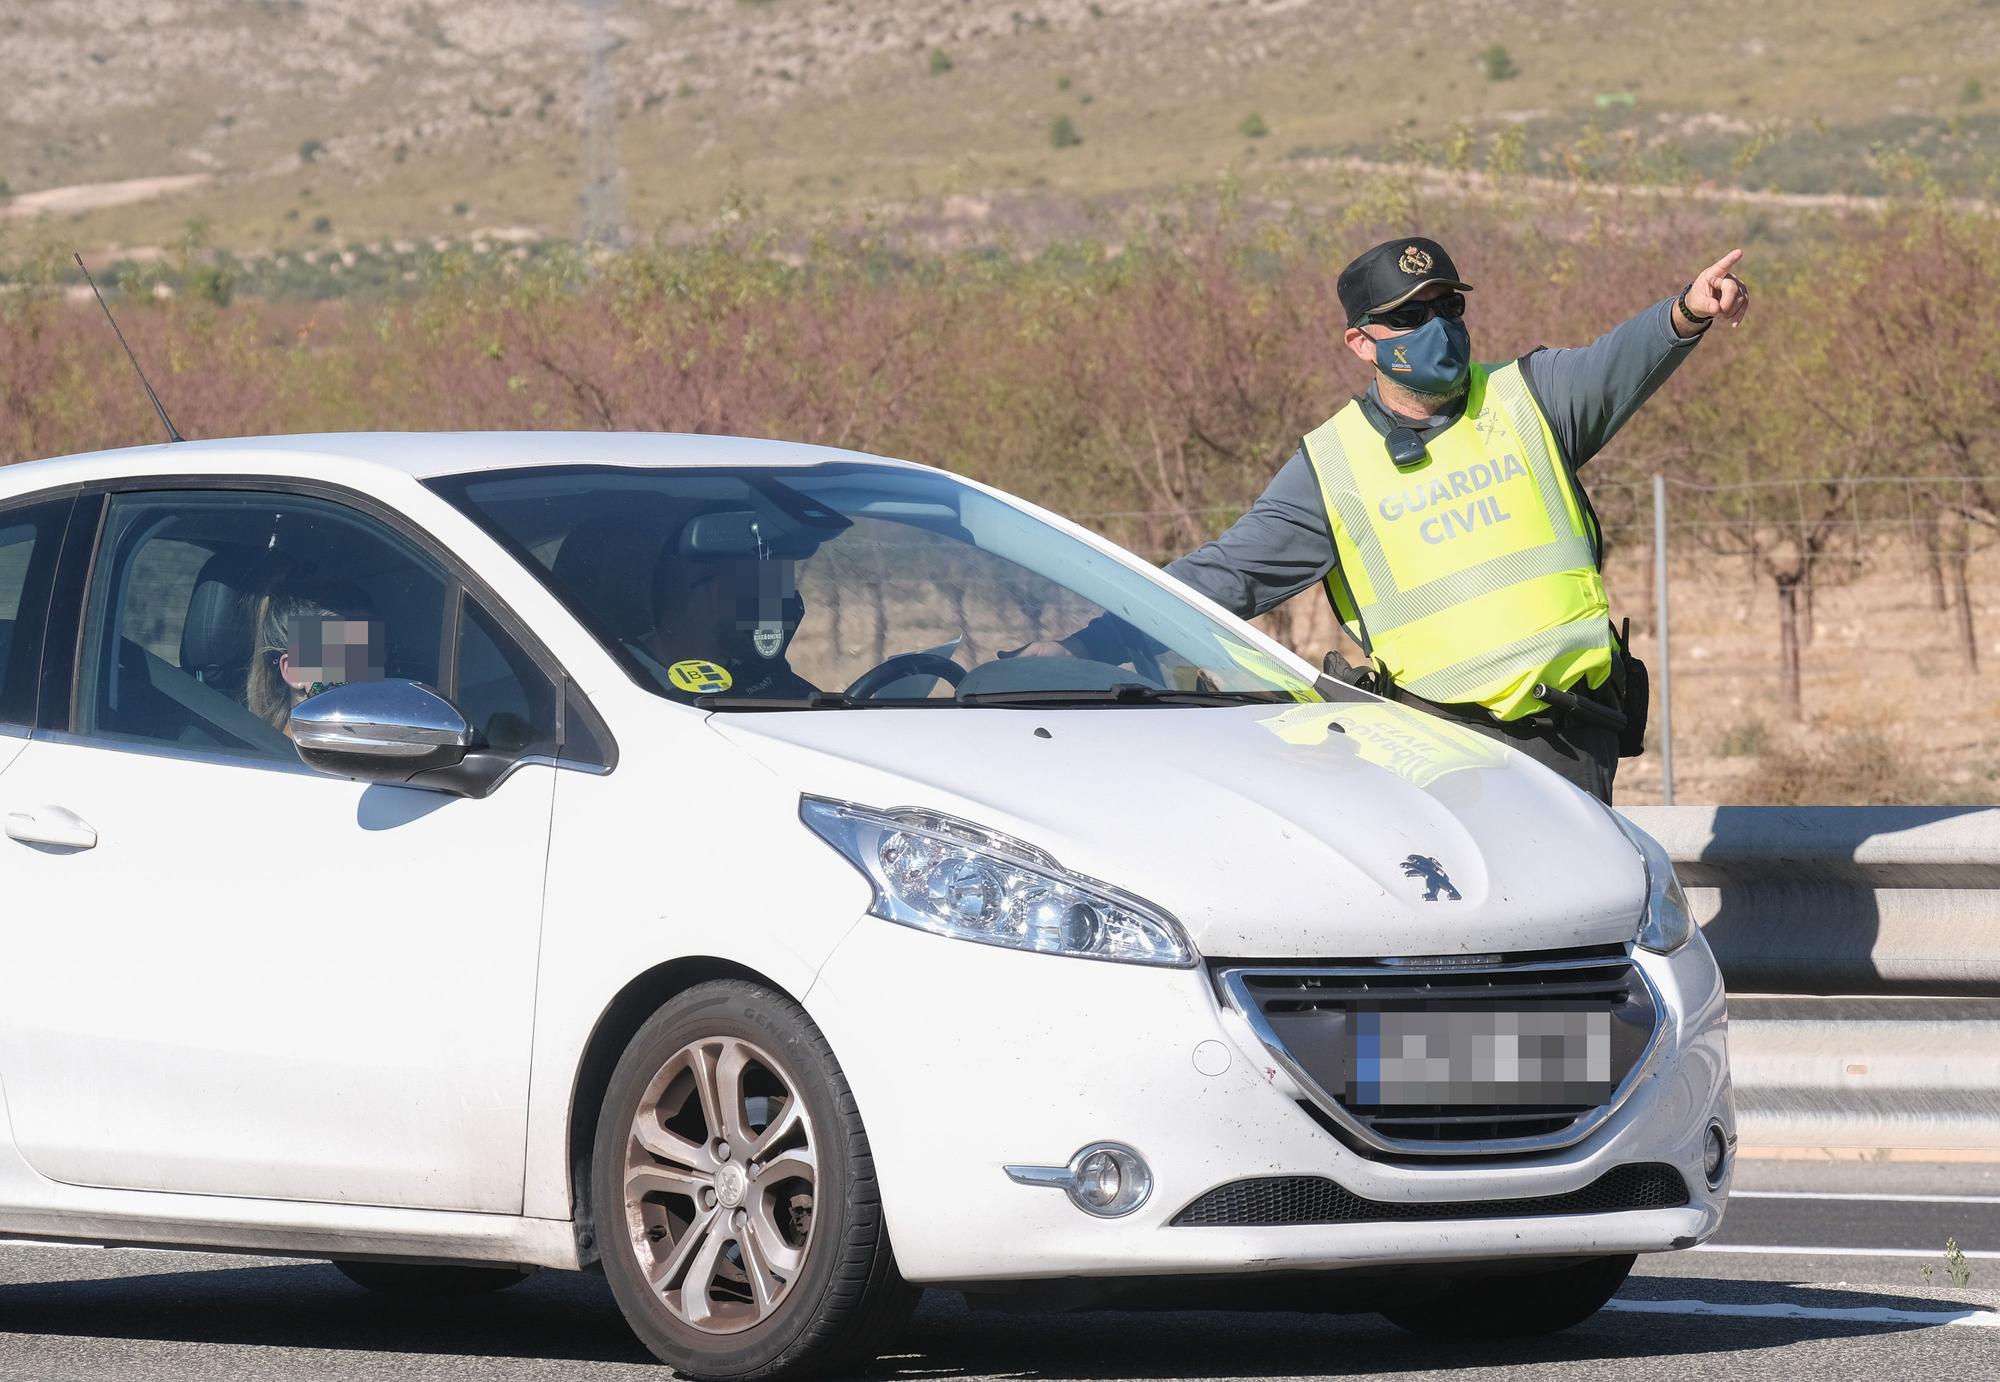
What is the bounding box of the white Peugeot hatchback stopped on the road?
[0,434,1734,1378]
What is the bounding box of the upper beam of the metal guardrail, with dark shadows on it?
[1624,806,2000,998]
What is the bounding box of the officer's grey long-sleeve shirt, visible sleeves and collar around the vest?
[1152,298,1700,634]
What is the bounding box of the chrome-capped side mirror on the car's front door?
[292,680,490,796]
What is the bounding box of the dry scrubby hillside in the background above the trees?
[0,0,2000,248]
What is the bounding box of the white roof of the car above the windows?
[0,432,922,494]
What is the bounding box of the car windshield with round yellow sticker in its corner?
[432,462,1320,710]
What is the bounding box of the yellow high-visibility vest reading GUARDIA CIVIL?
[1304,362,1614,720]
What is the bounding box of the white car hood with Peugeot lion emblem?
[710,702,1646,958]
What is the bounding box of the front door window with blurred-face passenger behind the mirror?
[74,490,446,762]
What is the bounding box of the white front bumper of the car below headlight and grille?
[806,918,1736,1282]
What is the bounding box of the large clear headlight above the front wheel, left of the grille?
[798,796,1194,968]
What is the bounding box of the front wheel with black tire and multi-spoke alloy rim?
[590,980,920,1382]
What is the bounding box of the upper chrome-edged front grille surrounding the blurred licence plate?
[1216,946,1658,1156]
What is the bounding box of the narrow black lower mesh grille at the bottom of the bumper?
[1174,1164,1688,1228]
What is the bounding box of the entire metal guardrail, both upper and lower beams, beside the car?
[1624,806,2000,1158]
